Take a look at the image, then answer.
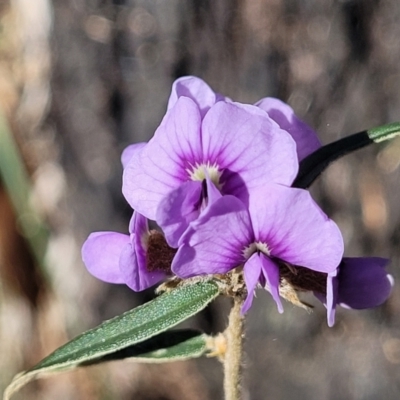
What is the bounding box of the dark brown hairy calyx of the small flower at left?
[146,230,177,273]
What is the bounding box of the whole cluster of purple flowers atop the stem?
[82,77,391,325]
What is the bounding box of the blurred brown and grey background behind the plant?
[0,0,400,400]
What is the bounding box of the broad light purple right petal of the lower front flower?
[249,184,343,272]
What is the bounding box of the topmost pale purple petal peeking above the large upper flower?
[168,76,224,118]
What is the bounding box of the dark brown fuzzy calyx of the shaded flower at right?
[278,261,327,295]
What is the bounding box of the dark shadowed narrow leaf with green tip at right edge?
[292,122,400,189]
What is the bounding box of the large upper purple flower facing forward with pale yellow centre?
[122,96,298,247]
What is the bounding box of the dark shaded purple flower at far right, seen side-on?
[315,257,393,326]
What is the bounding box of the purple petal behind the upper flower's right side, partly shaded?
[255,97,321,161]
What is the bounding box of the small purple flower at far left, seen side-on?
[82,212,172,291]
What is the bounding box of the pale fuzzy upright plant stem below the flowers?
[224,296,244,400]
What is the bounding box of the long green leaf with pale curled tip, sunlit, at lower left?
[4,280,219,400]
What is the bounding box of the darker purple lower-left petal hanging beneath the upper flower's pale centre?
[156,181,202,247]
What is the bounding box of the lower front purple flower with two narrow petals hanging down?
[172,184,343,312]
